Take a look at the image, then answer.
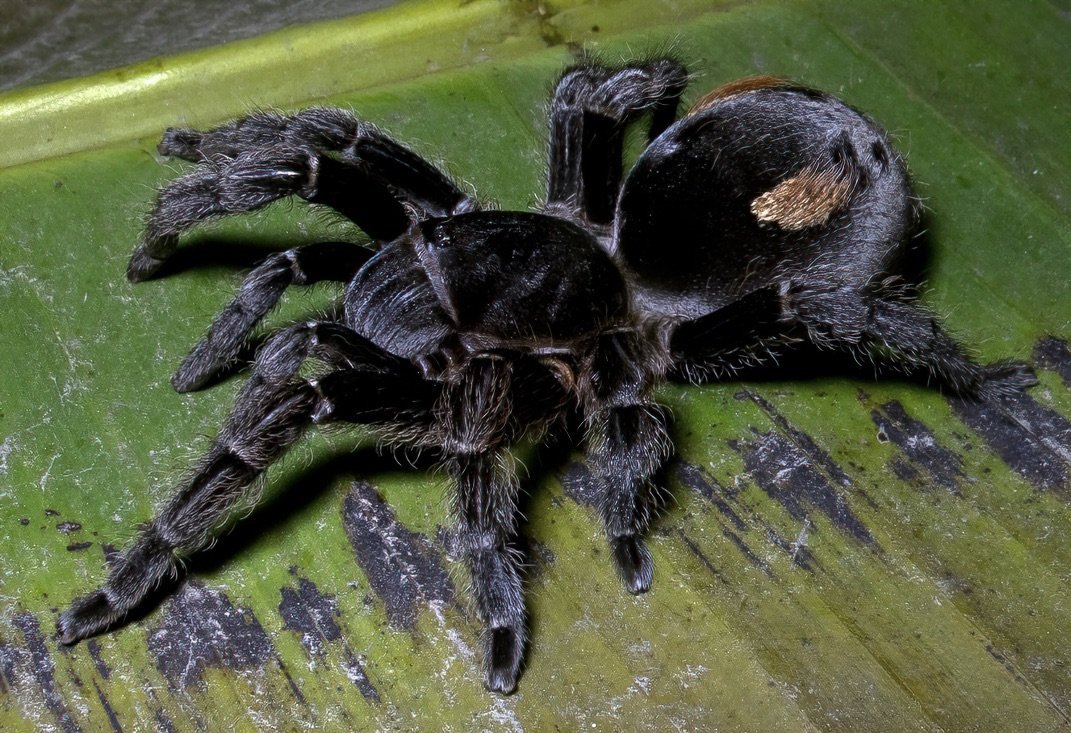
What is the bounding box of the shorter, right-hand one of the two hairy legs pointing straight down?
[587,331,672,594]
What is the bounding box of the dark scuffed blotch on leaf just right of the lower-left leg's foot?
[149,583,274,689]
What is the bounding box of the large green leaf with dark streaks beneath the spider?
[0,0,1071,731]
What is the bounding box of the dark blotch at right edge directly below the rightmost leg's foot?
[950,394,1071,490]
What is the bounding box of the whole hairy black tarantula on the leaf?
[59,59,1035,692]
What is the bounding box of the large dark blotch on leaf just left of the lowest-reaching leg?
[342,481,454,629]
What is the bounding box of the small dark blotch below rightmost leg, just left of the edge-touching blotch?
[871,400,964,495]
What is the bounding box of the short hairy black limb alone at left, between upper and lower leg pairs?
[171,242,372,392]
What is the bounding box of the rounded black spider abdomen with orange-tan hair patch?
[617,79,915,316]
